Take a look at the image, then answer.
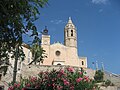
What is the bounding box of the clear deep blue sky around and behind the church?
[24,0,120,74]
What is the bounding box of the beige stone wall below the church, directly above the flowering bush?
[20,65,95,79]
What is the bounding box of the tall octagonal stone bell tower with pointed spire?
[64,17,77,48]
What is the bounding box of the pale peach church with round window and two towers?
[41,17,87,68]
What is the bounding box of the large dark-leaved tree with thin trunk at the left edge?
[0,0,48,82]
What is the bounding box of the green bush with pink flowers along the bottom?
[8,67,97,90]
